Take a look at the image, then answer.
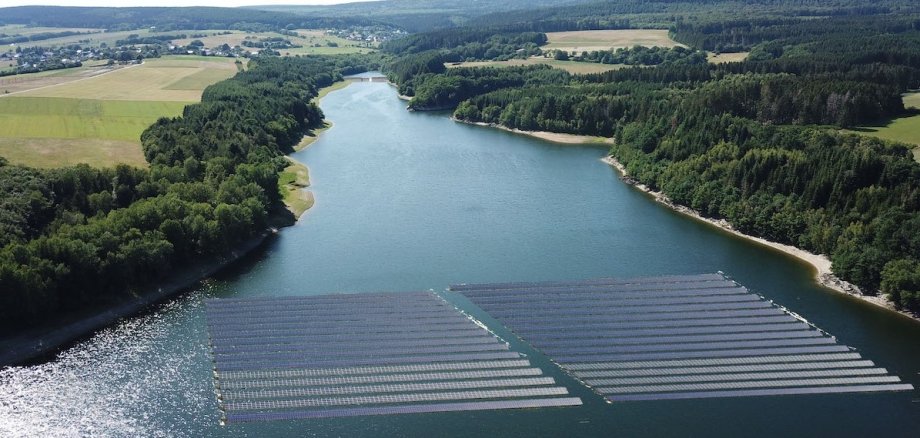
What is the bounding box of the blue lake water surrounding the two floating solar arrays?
[0,83,920,437]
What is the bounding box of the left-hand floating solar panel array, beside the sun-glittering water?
[206,292,581,422]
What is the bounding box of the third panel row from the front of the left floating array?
[222,377,556,400]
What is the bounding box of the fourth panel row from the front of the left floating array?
[220,368,543,389]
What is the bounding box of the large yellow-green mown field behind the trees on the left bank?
[0,57,237,167]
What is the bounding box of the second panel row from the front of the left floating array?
[224,387,569,411]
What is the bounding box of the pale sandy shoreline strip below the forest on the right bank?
[601,155,920,321]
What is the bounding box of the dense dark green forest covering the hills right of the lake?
[388,4,920,312]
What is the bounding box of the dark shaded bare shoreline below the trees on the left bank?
[0,229,277,368]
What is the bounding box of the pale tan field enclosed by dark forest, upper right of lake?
[543,29,682,53]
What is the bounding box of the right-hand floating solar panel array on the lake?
[451,274,913,401]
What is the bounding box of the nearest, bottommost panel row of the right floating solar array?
[608,384,914,401]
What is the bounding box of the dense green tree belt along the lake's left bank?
[0,56,376,328]
